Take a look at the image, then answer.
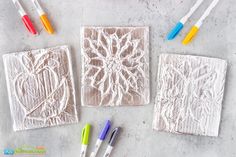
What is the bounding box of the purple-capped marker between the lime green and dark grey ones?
[90,120,111,157]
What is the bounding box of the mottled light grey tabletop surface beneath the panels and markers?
[0,0,236,157]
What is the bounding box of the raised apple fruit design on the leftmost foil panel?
[14,52,70,127]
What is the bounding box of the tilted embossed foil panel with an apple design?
[3,46,78,131]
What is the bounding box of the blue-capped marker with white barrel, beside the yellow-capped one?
[167,0,204,40]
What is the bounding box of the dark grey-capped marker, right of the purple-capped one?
[103,127,121,157]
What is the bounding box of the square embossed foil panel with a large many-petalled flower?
[81,27,150,106]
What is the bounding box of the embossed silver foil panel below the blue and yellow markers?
[153,54,227,136]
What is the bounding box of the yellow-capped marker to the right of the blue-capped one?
[182,0,219,45]
